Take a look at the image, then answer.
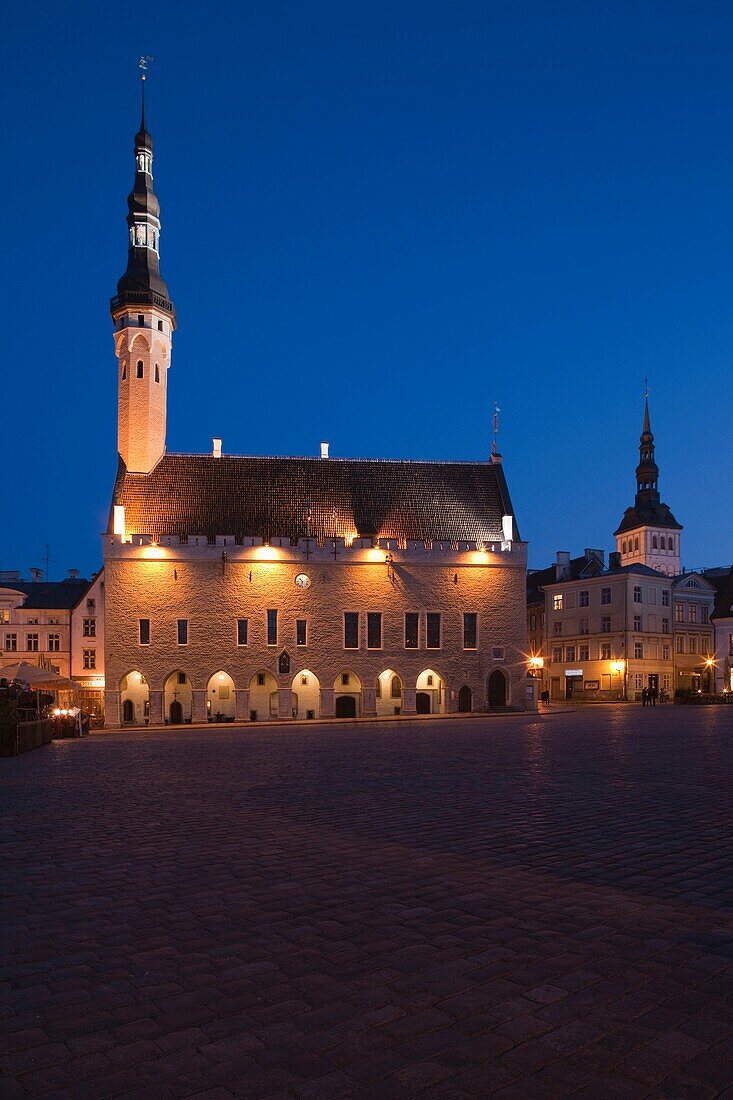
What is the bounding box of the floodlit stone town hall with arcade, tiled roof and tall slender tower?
[103,85,527,725]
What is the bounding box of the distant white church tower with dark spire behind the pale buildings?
[614,394,682,576]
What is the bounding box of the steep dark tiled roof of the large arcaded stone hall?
[113,454,519,542]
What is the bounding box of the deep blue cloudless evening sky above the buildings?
[0,0,733,578]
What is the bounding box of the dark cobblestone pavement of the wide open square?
[0,706,733,1100]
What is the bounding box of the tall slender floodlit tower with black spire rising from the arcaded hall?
[109,72,176,473]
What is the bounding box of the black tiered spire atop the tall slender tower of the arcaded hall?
[110,75,175,325]
